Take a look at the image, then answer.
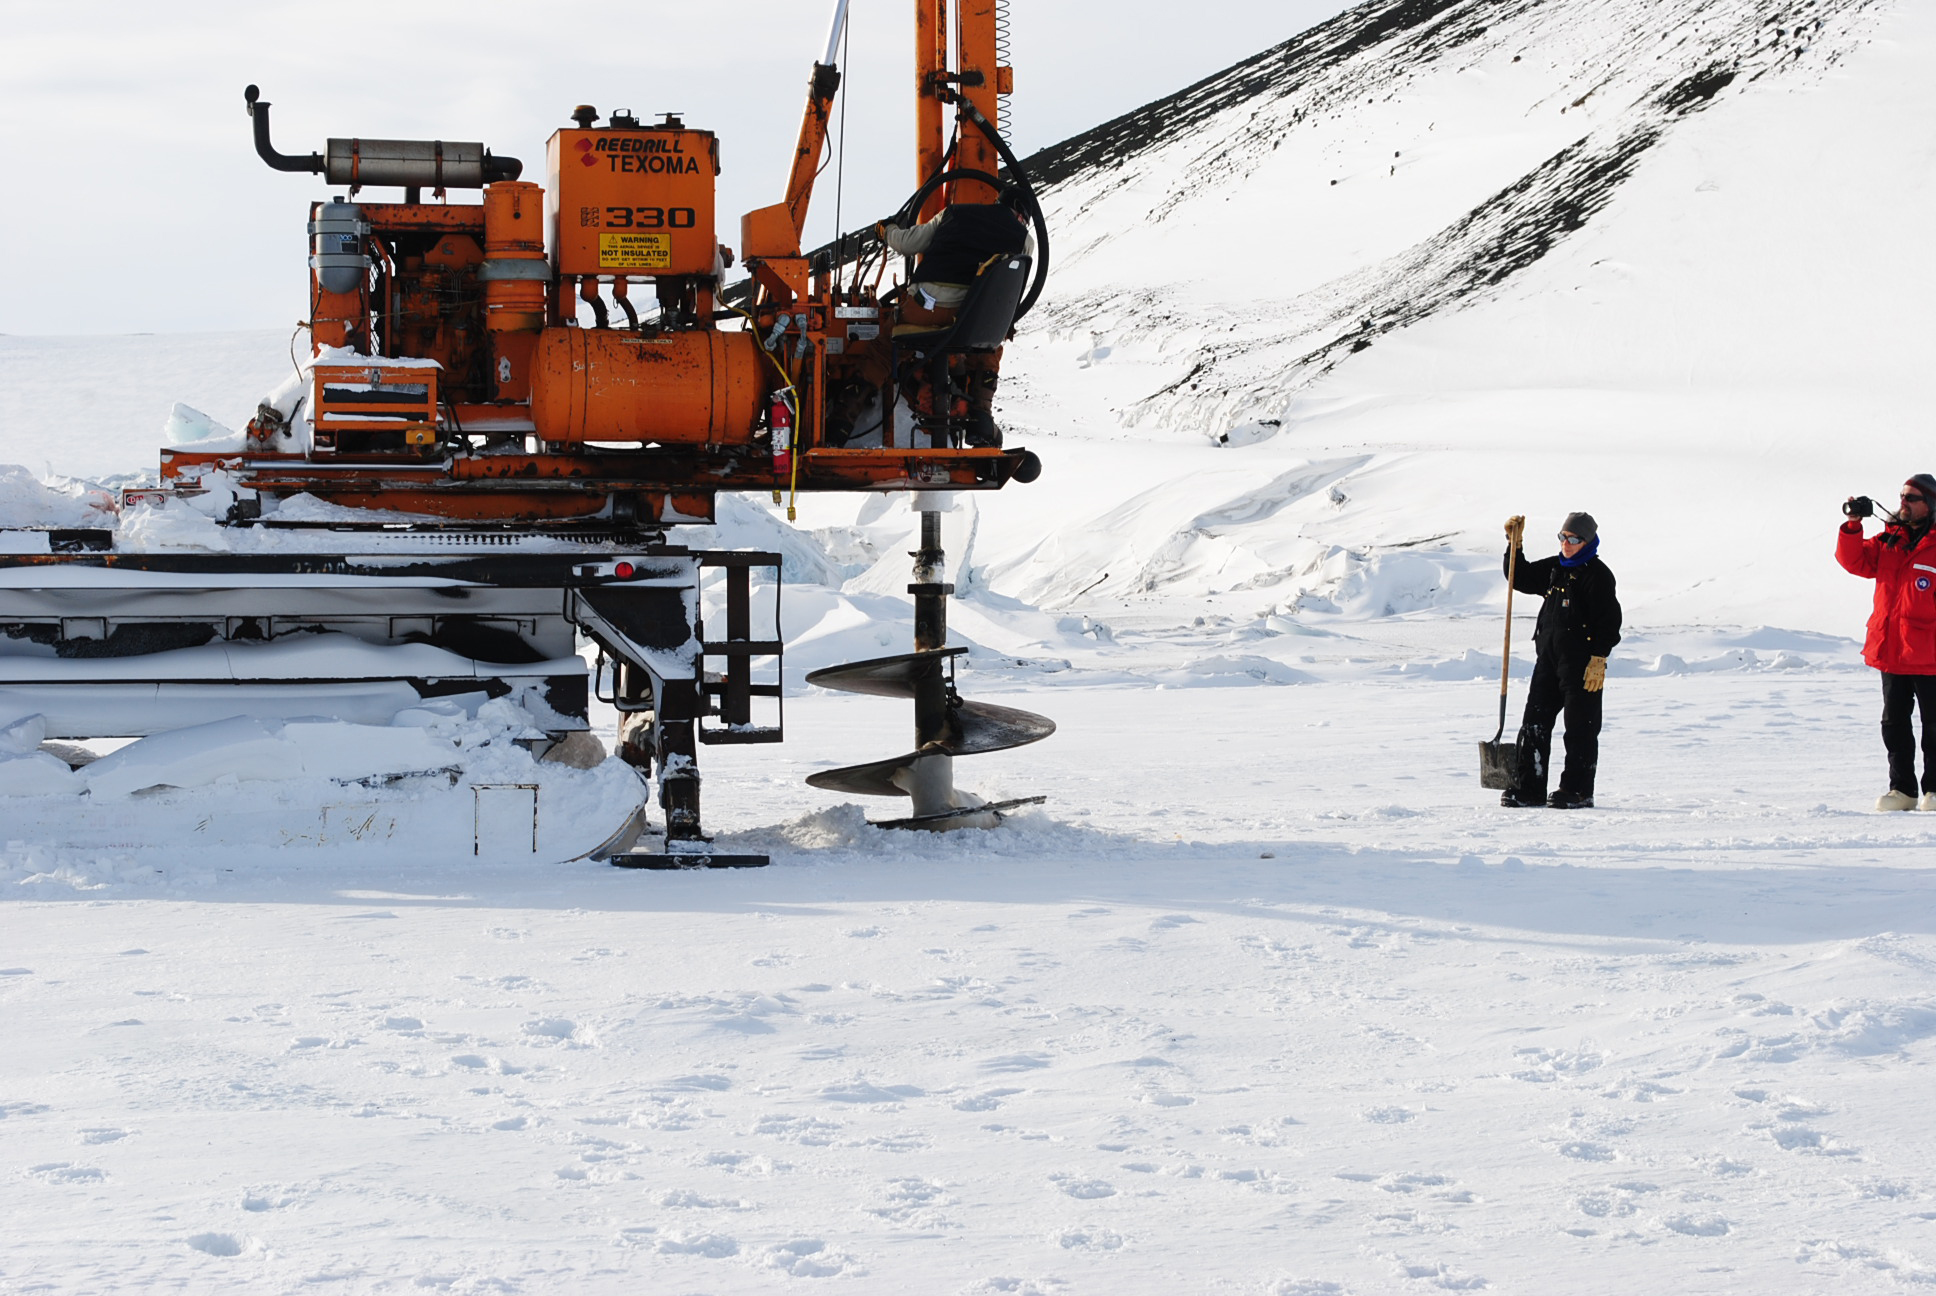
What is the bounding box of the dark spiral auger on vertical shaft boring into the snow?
[807,496,1055,831]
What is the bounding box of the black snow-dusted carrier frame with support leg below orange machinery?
[0,529,784,868]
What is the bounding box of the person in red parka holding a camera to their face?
[1835,464,1936,810]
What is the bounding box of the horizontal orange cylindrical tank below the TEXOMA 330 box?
[530,327,767,446]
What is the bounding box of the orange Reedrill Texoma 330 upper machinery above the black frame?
[172,0,1047,527]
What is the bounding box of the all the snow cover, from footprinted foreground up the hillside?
[0,0,1936,1296]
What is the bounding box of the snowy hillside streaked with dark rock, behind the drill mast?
[1024,0,1888,437]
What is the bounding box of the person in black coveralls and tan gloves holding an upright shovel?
[1498,513,1620,810]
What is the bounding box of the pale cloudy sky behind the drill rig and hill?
[0,0,1347,335]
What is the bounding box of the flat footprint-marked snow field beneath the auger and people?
[0,670,1936,1292]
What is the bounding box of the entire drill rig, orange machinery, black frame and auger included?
[0,0,1053,866]
